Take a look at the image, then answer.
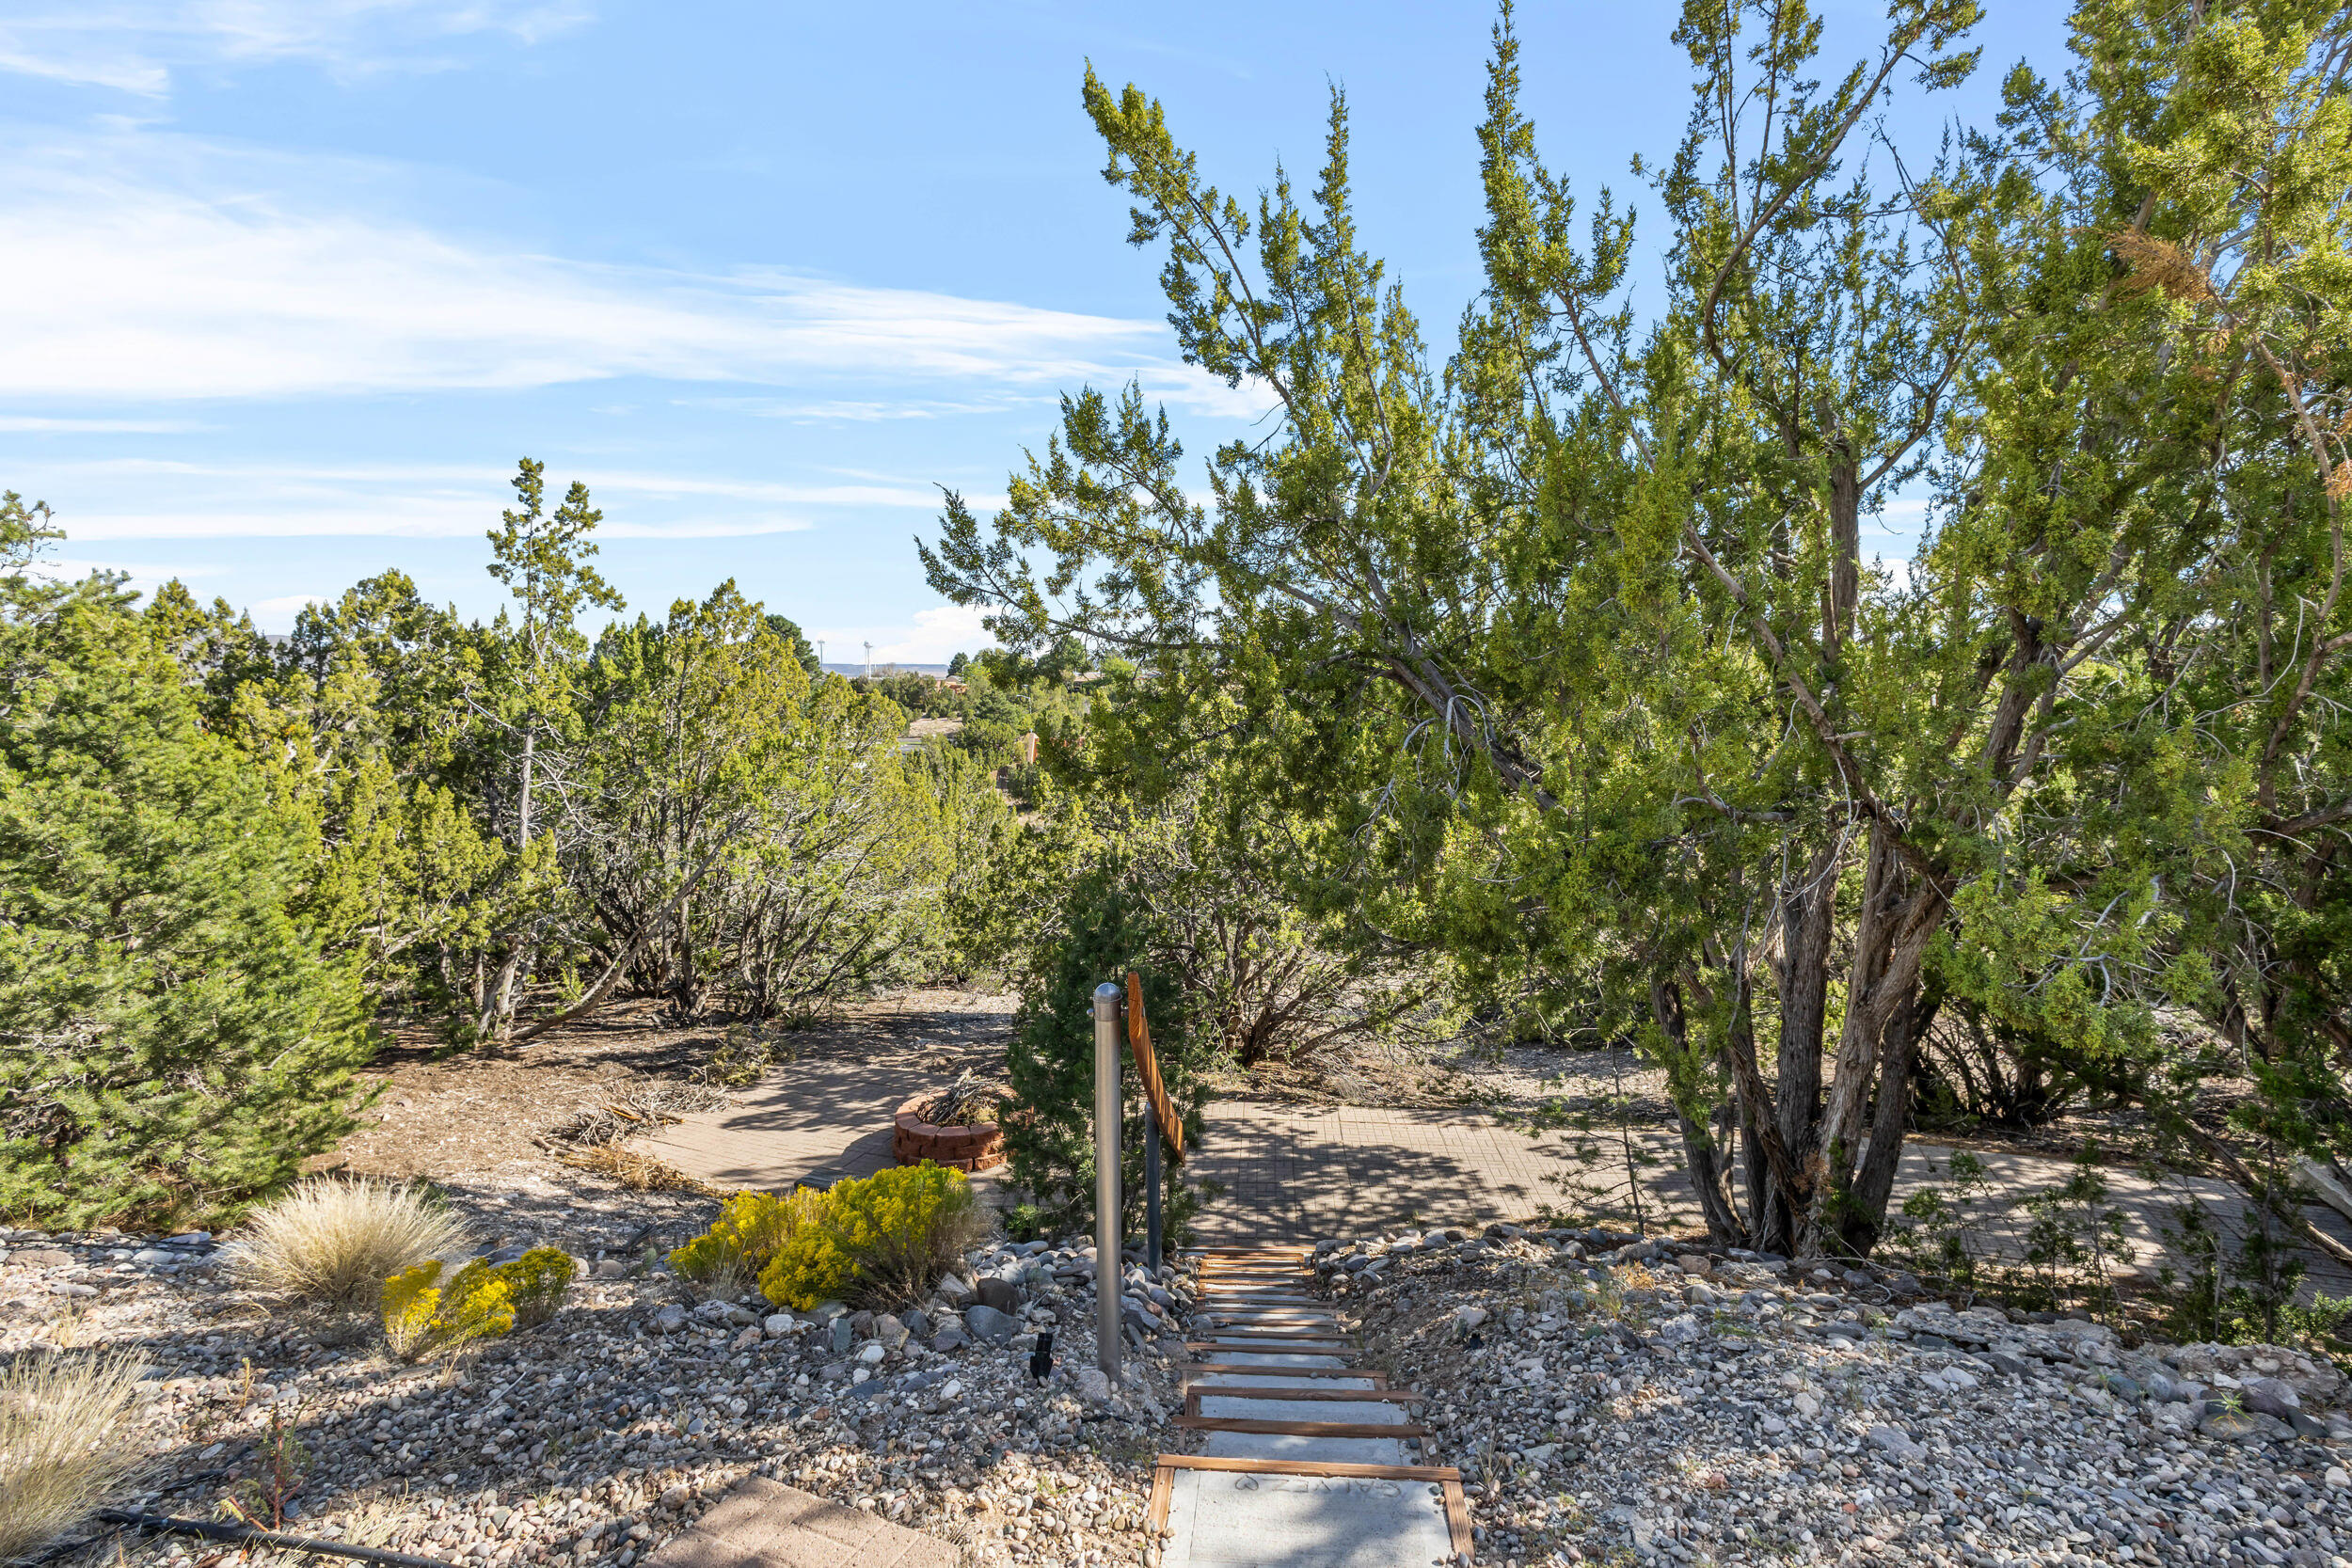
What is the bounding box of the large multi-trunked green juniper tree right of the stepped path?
[925,0,2352,1253]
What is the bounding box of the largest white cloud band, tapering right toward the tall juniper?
[0,132,1263,411]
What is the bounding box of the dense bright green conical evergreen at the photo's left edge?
[0,496,374,1225]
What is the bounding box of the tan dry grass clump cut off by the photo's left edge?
[0,1354,146,1561]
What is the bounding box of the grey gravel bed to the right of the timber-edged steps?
[1317,1227,2352,1568]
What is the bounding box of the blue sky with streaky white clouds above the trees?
[0,0,2063,663]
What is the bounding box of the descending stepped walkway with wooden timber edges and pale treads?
[1148,1248,1472,1568]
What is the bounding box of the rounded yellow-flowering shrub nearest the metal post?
[760,1162,988,1312]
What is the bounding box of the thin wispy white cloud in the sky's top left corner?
[0,0,591,96]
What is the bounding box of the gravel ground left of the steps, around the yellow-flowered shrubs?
[0,1212,1193,1568]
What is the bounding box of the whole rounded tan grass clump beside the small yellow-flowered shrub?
[230,1180,466,1307]
